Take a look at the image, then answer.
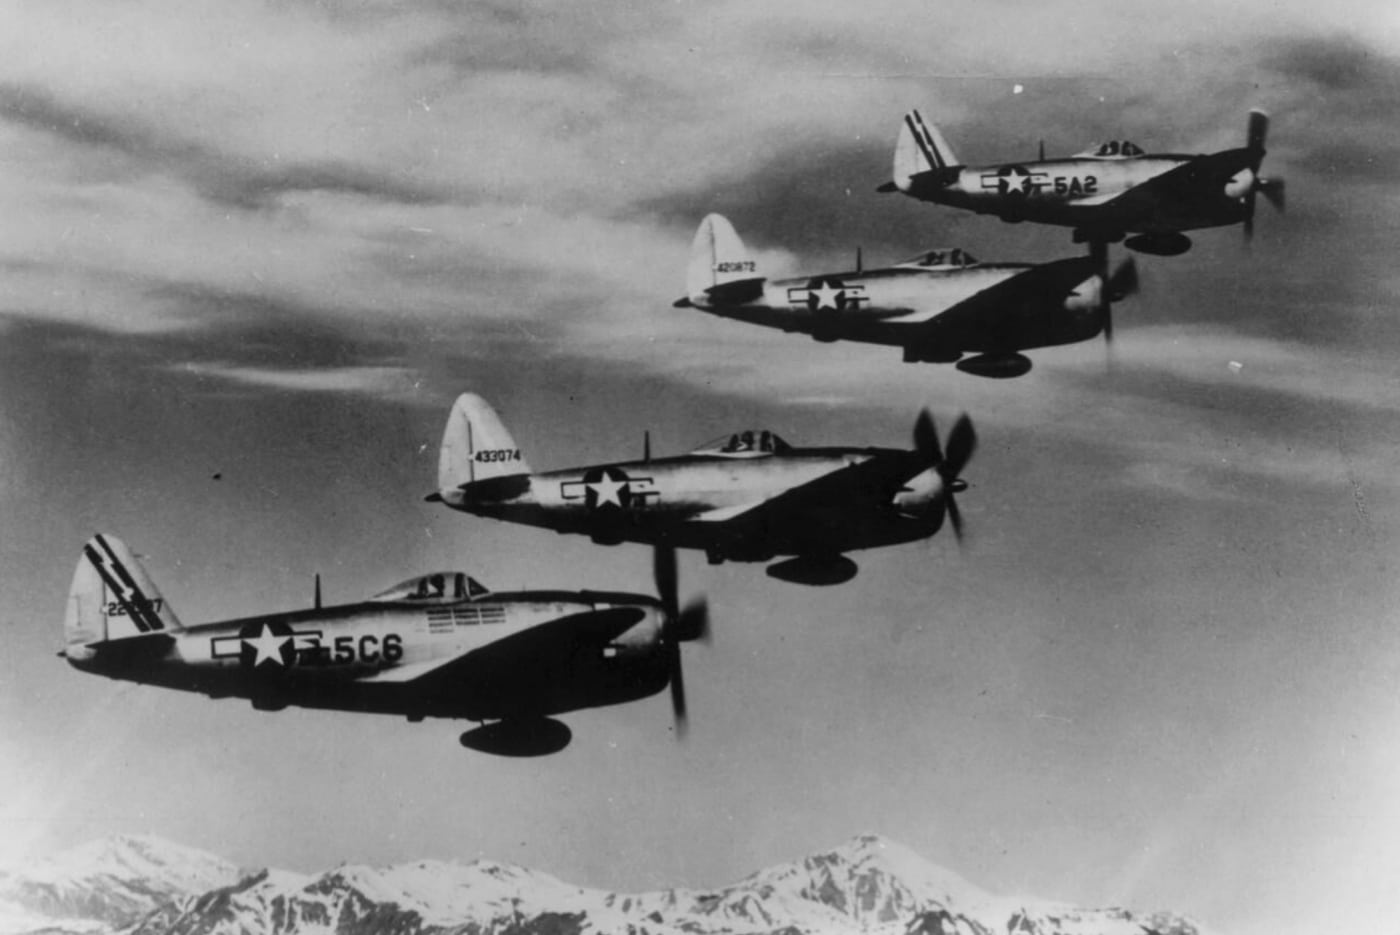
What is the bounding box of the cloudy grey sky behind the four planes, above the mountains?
[0,0,1400,935]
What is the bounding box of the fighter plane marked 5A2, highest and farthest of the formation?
[879,111,1284,256]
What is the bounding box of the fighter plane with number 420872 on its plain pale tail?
[675,214,1137,377]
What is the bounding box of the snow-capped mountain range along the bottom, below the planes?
[0,836,1203,935]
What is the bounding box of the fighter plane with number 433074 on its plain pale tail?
[428,393,977,584]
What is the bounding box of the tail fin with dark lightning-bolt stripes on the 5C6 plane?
[63,533,183,649]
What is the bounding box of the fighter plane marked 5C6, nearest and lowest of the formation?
[60,535,707,756]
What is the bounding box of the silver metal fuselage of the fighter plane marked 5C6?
[66,591,668,719]
